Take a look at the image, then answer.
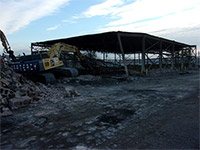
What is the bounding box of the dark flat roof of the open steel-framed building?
[32,31,194,54]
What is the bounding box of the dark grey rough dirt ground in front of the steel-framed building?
[0,70,200,149]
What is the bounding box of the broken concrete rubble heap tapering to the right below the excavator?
[0,57,80,116]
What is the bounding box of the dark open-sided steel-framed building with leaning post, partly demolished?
[31,31,197,76]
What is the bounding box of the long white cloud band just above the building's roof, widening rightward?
[99,8,200,32]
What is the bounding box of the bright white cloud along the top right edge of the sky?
[105,0,199,26]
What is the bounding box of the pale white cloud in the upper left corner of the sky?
[0,0,70,34]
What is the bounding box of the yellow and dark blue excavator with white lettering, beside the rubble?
[0,31,93,83]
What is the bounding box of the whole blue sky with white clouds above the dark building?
[0,0,200,55]
